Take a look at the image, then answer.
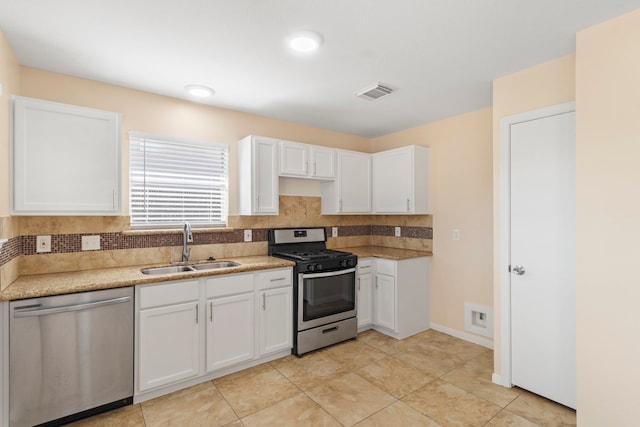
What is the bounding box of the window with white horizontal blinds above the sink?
[129,132,229,228]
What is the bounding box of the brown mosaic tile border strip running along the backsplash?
[0,225,433,266]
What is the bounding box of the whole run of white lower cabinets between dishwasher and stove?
[135,268,293,401]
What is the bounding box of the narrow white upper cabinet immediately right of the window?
[238,136,280,215]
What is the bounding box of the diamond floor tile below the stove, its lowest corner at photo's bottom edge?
[307,373,395,426]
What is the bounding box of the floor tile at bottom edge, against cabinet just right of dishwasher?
[142,382,238,427]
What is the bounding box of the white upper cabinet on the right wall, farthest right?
[372,145,430,214]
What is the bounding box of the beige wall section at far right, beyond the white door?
[576,10,640,427]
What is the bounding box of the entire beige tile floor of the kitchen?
[69,330,576,427]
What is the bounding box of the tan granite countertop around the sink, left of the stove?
[0,255,295,301]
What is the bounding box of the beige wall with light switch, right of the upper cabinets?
[372,108,493,342]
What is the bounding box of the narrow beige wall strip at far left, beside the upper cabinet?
[0,30,20,221]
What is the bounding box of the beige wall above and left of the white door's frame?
[493,54,575,374]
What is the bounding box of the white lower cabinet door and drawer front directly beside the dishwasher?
[136,281,200,391]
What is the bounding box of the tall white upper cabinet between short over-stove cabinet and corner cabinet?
[322,150,371,215]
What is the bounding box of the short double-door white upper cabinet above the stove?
[280,141,335,179]
